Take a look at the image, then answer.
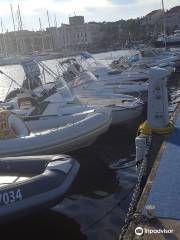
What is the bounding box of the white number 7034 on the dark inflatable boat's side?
[0,189,23,205]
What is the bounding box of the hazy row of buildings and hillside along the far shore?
[0,6,180,56]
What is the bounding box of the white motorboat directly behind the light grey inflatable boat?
[3,90,109,132]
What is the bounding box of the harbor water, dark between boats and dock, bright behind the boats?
[0,51,180,240]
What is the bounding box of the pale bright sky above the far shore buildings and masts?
[0,0,180,32]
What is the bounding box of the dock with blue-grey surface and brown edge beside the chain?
[123,104,180,240]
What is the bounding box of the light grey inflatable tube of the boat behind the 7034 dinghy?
[0,111,111,157]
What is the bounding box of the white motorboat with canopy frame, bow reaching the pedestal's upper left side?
[58,59,148,98]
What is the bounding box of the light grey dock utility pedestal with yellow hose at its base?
[135,68,169,165]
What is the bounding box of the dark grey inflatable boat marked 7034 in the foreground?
[0,155,79,223]
